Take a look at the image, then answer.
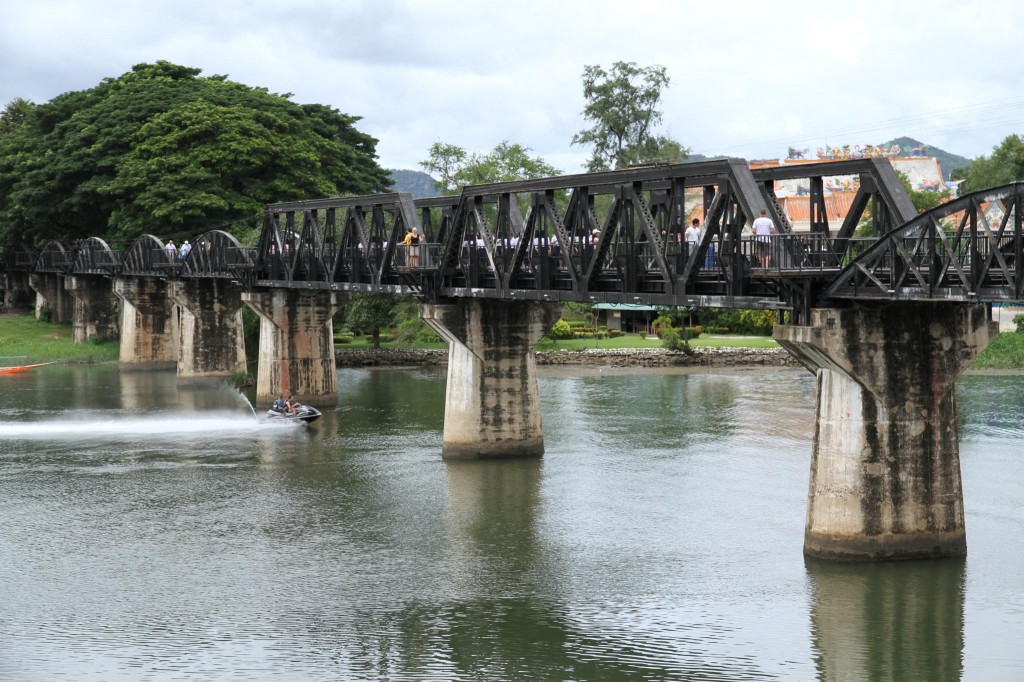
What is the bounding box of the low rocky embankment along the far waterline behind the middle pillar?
[335,348,798,367]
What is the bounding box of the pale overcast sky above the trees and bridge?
[0,0,1024,172]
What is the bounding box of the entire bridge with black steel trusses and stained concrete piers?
[4,159,1024,559]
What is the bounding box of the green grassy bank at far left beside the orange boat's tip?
[0,312,120,367]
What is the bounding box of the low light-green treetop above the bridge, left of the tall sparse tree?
[420,140,560,195]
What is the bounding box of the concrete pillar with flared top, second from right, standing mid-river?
[420,299,561,459]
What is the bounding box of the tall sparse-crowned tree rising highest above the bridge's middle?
[572,61,689,171]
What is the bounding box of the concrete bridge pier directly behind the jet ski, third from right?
[242,289,338,406]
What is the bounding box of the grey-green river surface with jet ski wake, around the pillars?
[0,367,1024,681]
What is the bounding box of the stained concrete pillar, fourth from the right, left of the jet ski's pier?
[169,278,246,379]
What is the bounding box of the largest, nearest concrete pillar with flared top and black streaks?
[775,302,997,560]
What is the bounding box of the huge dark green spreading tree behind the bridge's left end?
[0,61,390,244]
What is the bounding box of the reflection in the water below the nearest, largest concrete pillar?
[806,558,966,680]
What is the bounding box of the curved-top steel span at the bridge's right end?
[821,182,1024,302]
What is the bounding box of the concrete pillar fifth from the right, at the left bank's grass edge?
[114,278,179,370]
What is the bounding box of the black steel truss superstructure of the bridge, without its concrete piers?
[3,159,1024,323]
